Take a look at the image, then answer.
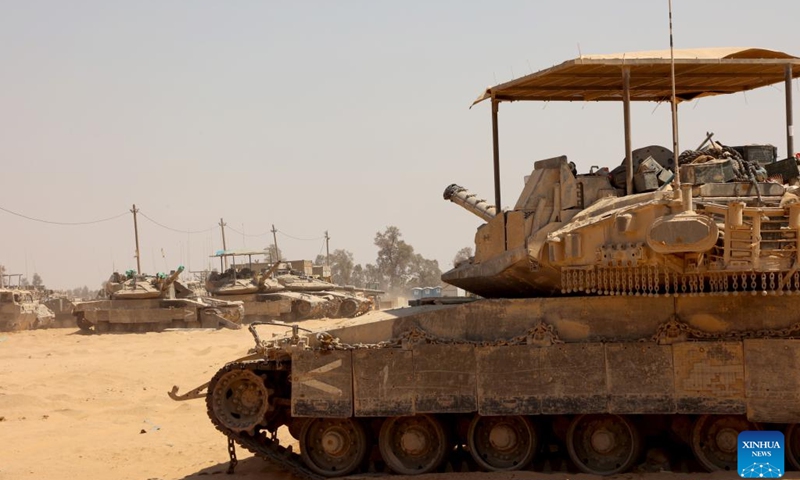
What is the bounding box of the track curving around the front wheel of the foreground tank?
[206,361,328,480]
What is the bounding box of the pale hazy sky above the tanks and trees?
[0,0,800,288]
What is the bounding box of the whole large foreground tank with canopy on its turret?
[170,49,800,478]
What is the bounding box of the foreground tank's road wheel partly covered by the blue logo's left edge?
[692,415,759,472]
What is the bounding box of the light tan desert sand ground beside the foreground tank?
[0,329,800,480]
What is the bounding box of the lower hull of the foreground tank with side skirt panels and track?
[177,294,800,478]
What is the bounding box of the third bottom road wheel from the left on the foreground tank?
[467,415,538,471]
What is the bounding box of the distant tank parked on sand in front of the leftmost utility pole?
[72,266,244,333]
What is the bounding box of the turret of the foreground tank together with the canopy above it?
[442,48,800,297]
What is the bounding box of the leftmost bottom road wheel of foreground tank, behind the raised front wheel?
[300,418,367,477]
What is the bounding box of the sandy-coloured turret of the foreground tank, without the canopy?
[442,149,800,297]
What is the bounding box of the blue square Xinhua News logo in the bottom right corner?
[737,431,786,478]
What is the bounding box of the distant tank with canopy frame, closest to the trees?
[206,250,383,323]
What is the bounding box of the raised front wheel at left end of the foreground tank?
[211,369,269,435]
